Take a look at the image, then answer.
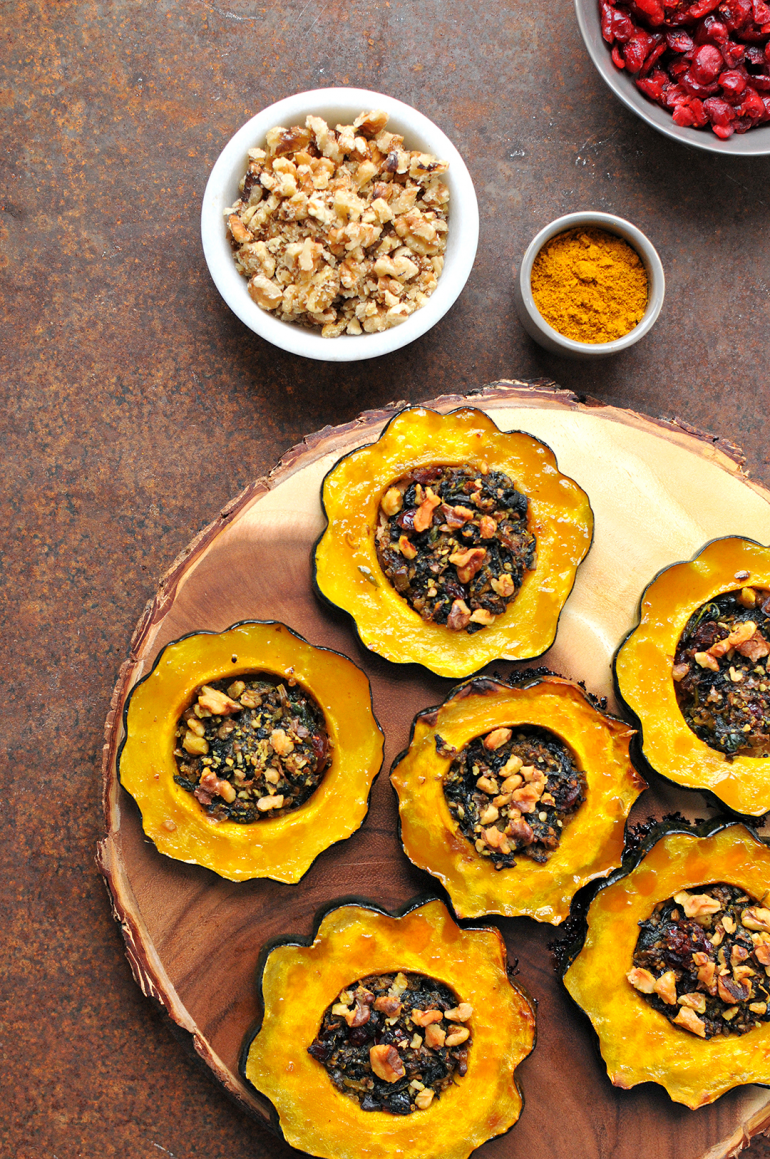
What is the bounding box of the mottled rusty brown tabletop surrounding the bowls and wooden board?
[0,0,770,1159]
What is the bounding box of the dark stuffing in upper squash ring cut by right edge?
[671,588,770,757]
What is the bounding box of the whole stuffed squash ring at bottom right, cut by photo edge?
[564,819,770,1108]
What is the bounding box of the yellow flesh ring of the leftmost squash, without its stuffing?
[118,622,383,883]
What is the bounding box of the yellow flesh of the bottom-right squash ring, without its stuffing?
[564,818,770,1109]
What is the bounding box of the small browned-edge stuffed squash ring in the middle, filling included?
[391,672,645,925]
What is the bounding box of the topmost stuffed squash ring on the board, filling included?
[315,407,594,677]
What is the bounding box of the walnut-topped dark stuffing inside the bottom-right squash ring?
[626,882,770,1038]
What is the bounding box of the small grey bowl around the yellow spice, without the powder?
[514,212,666,358]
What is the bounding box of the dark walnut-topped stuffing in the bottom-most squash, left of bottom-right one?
[307,971,473,1115]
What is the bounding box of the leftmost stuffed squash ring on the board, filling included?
[118,622,383,883]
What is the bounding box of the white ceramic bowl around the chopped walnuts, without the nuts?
[201,88,479,362]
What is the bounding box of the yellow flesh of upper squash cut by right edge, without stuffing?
[615,537,770,817]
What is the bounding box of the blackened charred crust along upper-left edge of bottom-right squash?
[547,812,770,982]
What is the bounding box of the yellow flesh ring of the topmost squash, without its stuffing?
[315,407,594,677]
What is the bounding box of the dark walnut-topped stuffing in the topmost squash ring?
[375,465,537,633]
